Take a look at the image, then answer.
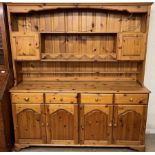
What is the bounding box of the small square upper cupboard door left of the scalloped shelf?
[11,32,40,60]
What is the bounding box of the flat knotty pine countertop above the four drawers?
[10,81,150,94]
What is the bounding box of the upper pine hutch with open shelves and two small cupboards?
[7,3,151,92]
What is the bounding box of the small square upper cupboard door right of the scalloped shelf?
[117,33,146,60]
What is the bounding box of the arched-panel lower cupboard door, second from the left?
[45,104,78,144]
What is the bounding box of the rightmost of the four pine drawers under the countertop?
[115,94,148,104]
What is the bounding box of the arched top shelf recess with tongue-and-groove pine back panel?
[11,9,146,32]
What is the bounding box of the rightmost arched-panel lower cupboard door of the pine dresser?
[114,105,147,145]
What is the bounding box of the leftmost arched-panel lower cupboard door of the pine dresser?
[12,104,46,144]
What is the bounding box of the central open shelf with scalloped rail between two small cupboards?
[41,32,117,61]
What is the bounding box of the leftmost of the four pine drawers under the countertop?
[11,93,43,104]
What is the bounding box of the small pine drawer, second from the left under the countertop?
[45,93,77,103]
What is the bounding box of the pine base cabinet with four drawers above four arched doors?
[12,93,148,150]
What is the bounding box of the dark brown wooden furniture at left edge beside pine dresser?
[0,3,14,151]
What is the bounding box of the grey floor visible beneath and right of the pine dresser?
[17,134,155,152]
